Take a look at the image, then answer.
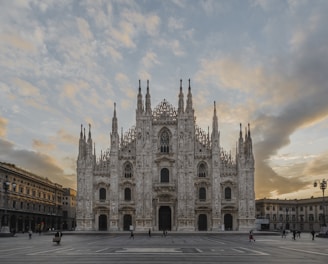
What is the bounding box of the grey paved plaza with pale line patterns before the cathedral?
[0,233,328,264]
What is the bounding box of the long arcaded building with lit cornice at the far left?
[0,162,63,232]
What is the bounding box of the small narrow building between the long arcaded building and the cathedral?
[63,188,76,230]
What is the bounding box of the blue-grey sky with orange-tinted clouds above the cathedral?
[0,0,328,199]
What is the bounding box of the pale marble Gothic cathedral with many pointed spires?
[76,80,255,232]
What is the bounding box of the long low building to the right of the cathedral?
[256,197,324,231]
